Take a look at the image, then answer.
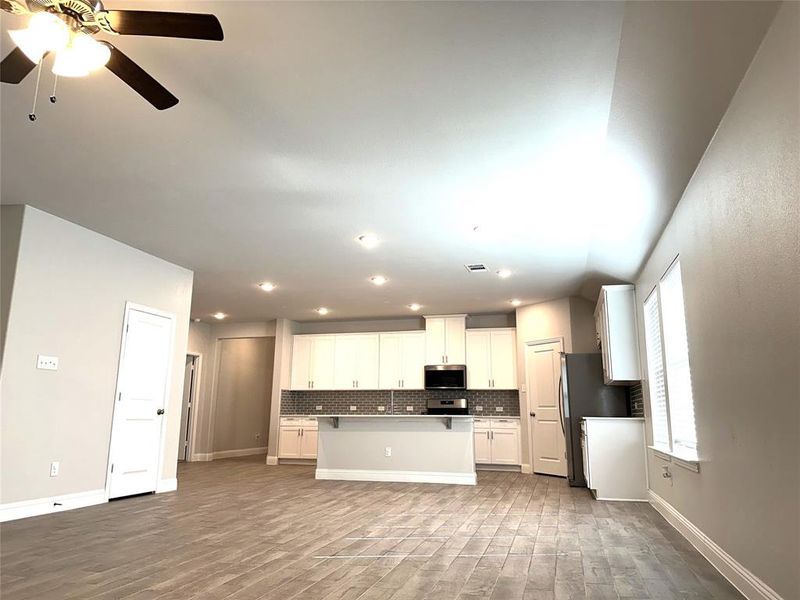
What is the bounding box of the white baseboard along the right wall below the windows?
[648,490,782,600]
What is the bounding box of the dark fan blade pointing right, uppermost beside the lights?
[107,10,223,41]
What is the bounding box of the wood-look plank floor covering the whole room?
[0,457,741,600]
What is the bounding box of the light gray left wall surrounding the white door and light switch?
[0,206,192,503]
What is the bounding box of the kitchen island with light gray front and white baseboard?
[316,415,476,485]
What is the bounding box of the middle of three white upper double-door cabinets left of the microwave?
[333,333,378,390]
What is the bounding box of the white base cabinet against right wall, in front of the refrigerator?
[581,417,647,500]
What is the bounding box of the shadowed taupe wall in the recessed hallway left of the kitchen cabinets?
[214,337,275,452]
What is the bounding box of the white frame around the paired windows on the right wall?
[642,255,700,472]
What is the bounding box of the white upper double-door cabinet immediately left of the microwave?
[379,331,425,390]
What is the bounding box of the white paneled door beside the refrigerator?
[525,342,567,477]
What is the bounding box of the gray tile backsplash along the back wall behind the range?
[281,390,519,417]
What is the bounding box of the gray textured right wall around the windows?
[636,2,800,600]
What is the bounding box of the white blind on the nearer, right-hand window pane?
[660,261,697,459]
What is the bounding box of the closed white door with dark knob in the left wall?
[109,307,174,498]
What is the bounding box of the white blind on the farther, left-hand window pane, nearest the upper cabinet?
[644,290,670,450]
